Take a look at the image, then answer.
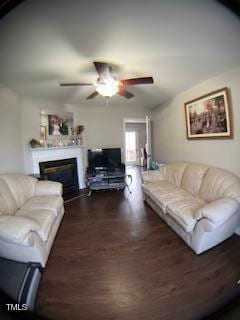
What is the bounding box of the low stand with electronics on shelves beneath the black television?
[86,167,132,196]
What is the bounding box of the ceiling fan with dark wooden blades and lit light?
[60,61,153,100]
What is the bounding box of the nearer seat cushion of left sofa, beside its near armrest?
[16,209,56,241]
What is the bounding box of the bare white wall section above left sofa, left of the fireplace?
[0,85,23,172]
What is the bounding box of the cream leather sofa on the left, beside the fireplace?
[0,174,64,267]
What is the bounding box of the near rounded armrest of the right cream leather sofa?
[195,198,239,226]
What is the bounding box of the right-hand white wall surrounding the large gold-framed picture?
[152,68,240,176]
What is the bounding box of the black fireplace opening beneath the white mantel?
[39,158,79,196]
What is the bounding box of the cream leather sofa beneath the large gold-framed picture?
[142,162,240,254]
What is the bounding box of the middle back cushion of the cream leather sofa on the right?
[181,163,209,196]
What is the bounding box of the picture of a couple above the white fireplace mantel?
[41,110,73,139]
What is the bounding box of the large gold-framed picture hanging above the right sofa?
[184,88,233,139]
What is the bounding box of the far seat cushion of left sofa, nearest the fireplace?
[21,196,63,216]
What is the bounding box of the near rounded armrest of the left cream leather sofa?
[0,215,40,246]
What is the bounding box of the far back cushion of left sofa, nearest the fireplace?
[0,173,37,208]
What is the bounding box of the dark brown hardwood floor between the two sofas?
[36,168,240,320]
